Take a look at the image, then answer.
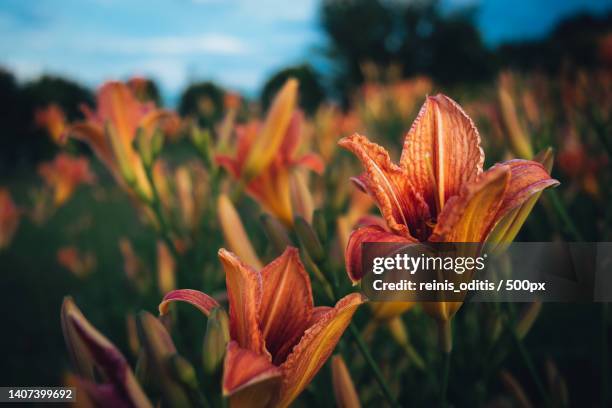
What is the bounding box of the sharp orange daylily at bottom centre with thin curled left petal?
[159,248,364,407]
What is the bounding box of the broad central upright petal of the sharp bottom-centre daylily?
[259,247,313,364]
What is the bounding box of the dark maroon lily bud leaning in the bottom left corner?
[61,298,152,408]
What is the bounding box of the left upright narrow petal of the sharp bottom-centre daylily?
[219,248,267,354]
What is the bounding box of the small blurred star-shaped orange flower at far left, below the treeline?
[38,153,96,207]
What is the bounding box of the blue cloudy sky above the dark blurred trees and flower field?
[0,0,612,99]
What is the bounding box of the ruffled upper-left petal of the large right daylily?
[338,134,429,238]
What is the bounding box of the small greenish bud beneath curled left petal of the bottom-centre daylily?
[202,307,229,374]
